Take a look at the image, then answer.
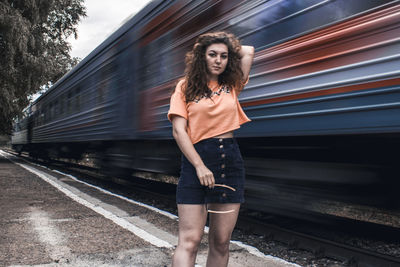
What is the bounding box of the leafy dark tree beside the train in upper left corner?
[0,0,86,134]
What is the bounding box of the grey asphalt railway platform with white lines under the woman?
[0,150,298,267]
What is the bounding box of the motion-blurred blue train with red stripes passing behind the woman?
[12,0,400,218]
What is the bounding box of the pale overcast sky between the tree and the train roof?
[69,0,150,59]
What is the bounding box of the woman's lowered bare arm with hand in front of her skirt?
[172,116,215,187]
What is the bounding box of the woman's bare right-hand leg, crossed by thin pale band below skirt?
[207,203,240,267]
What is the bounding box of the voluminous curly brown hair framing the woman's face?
[183,32,243,102]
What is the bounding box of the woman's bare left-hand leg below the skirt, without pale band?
[172,204,207,267]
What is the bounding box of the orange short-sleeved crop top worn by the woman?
[168,80,250,144]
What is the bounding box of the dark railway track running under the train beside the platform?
[8,151,400,267]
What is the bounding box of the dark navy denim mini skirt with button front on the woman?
[176,138,245,204]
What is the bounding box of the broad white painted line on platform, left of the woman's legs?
[0,150,173,248]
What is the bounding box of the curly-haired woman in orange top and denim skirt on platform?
[168,32,254,267]
